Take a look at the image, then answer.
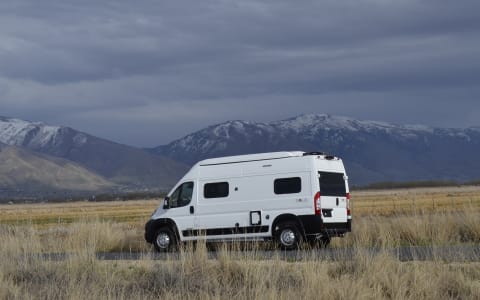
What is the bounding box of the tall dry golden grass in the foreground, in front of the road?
[0,223,480,299]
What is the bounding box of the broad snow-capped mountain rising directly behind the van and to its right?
[151,114,480,184]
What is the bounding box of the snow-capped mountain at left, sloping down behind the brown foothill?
[0,117,186,188]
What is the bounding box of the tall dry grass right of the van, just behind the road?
[338,206,480,248]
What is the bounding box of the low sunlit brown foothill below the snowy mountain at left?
[0,143,115,198]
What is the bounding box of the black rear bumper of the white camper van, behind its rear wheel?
[299,215,352,237]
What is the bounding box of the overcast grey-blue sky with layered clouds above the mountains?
[0,0,480,147]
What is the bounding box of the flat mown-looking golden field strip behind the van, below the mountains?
[0,186,480,227]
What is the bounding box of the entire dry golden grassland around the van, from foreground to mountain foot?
[0,187,480,299]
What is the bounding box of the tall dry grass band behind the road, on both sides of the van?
[0,206,480,253]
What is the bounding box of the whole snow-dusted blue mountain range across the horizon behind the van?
[0,114,480,195]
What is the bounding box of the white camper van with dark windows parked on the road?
[145,151,352,251]
